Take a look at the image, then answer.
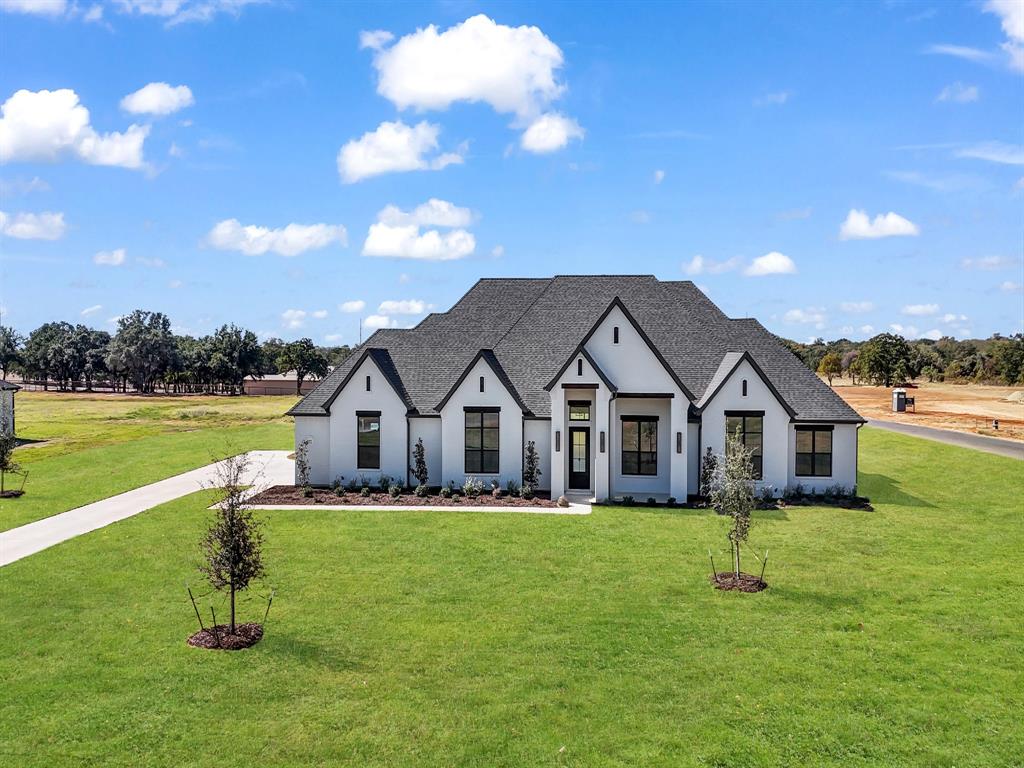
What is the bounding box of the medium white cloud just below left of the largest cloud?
[338,120,465,184]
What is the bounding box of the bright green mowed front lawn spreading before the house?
[0,428,1024,768]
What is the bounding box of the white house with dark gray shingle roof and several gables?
[289,275,864,500]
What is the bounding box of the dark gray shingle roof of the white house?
[289,274,860,421]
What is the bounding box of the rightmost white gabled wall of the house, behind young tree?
[701,359,796,495]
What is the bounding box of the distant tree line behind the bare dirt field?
[780,334,1024,387]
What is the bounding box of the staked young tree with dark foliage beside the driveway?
[200,454,264,635]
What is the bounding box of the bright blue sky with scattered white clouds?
[0,0,1024,343]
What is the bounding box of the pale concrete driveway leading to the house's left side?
[0,451,295,565]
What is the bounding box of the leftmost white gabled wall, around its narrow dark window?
[328,357,409,483]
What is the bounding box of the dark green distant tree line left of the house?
[0,309,351,394]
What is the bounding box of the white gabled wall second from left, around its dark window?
[441,359,523,485]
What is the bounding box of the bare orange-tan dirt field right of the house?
[833,379,1024,440]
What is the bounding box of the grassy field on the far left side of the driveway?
[0,392,297,530]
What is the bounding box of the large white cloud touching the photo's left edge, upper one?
[0,88,150,168]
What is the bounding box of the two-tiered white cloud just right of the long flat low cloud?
[362,200,476,261]
